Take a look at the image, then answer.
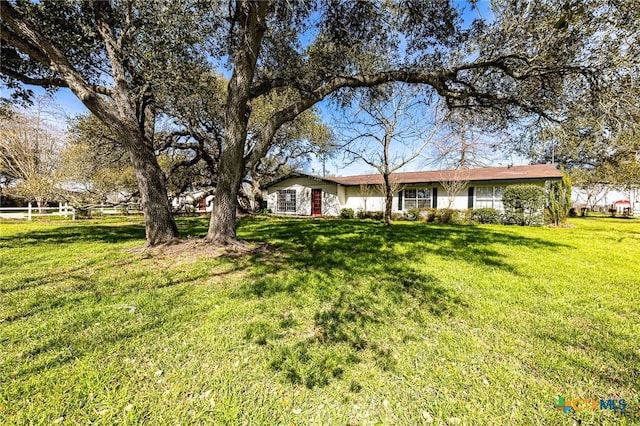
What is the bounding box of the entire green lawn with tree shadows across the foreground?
[0,218,640,425]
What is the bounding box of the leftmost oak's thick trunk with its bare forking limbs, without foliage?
[0,2,178,246]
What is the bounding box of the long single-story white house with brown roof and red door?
[264,164,562,216]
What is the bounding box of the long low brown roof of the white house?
[266,164,562,187]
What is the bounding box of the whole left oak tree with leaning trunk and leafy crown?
[0,0,215,245]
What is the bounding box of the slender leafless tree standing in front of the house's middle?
[340,84,438,225]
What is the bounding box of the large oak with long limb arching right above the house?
[199,0,629,243]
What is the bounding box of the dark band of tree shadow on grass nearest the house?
[236,219,570,280]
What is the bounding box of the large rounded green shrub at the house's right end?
[502,185,545,226]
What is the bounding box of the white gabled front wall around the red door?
[267,178,341,216]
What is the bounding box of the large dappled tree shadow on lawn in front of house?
[235,219,561,389]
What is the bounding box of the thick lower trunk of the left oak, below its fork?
[125,130,179,246]
